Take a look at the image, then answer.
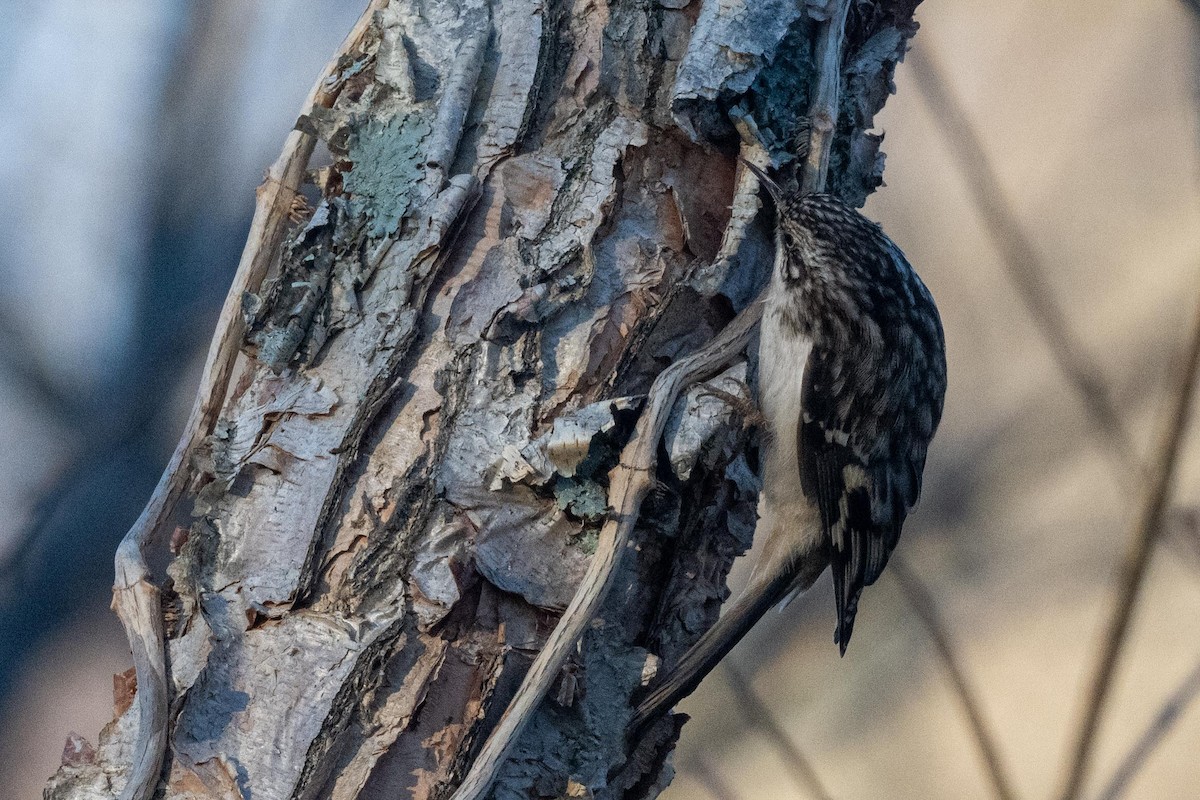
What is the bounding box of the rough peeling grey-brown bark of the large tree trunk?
[47,0,919,800]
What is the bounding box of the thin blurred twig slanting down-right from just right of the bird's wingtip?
[887,563,1016,800]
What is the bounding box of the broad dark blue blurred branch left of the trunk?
[0,0,245,704]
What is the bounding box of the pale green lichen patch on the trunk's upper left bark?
[342,114,431,239]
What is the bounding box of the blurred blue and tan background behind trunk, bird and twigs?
[0,0,1200,800]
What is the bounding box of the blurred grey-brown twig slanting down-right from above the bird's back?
[906,48,1136,465]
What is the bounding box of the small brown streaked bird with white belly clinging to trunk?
[630,162,946,730]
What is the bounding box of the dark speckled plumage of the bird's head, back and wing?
[760,190,946,652]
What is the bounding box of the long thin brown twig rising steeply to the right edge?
[1060,292,1200,800]
